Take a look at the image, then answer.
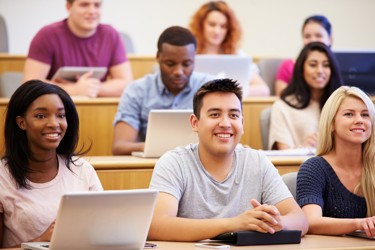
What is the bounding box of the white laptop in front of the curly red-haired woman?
[194,55,253,93]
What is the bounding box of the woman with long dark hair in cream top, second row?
[269,42,342,149]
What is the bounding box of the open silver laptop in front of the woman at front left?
[21,189,158,250]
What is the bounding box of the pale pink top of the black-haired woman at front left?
[0,157,103,247]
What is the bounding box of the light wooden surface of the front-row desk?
[5,235,375,250]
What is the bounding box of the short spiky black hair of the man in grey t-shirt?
[193,78,242,119]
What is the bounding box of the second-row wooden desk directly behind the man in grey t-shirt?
[85,156,309,190]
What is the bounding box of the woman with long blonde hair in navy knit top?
[297,86,375,237]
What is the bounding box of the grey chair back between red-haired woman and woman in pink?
[258,58,285,95]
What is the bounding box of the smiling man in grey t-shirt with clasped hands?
[149,79,307,241]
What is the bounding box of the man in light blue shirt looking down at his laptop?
[112,26,213,155]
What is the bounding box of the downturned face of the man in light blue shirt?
[157,43,195,95]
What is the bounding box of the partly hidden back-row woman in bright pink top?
[275,15,332,95]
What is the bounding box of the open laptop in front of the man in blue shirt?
[132,109,198,158]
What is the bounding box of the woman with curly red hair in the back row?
[190,1,270,97]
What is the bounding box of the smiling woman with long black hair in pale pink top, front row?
[0,80,103,247]
